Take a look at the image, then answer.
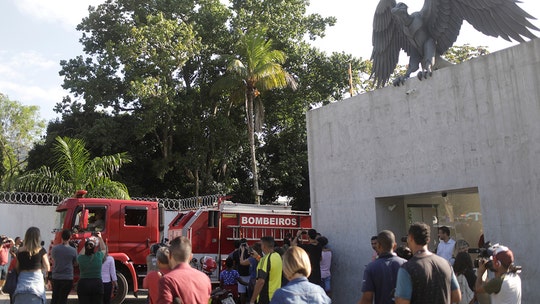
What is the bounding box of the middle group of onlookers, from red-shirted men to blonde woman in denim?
[140,229,332,304]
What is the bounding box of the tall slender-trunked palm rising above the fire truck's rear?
[217,28,296,204]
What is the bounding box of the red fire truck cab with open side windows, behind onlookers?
[53,195,164,303]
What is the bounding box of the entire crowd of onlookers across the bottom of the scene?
[0,223,521,304]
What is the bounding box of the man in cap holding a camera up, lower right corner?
[475,245,521,304]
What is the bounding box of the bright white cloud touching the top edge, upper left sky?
[15,0,105,29]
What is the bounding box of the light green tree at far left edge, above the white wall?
[0,93,45,190]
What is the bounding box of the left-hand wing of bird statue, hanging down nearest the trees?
[371,0,411,87]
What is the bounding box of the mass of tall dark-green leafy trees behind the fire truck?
[43,0,358,209]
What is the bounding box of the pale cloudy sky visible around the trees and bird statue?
[0,0,540,120]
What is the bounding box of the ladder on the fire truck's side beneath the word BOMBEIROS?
[227,225,308,241]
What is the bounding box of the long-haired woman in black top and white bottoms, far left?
[13,227,50,304]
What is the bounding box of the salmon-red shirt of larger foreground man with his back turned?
[157,263,212,304]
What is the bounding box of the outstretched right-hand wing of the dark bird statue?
[422,0,539,54]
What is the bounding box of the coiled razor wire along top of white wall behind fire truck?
[0,191,224,211]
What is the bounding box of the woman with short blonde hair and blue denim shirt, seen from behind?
[270,246,332,304]
